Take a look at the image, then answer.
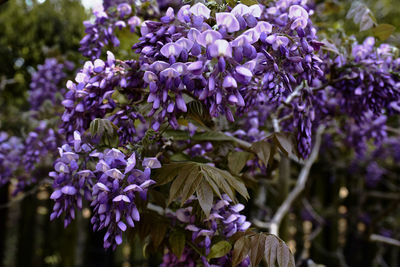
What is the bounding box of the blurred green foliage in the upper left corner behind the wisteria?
[0,0,87,132]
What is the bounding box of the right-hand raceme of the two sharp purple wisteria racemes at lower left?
[91,148,161,249]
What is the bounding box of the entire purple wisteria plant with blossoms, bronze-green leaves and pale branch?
[0,0,400,267]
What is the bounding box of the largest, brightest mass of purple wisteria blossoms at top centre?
[133,3,323,129]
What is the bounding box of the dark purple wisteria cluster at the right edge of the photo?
[331,37,400,122]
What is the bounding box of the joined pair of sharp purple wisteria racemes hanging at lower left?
[50,131,161,249]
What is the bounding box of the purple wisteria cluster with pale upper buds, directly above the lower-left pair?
[60,52,143,139]
